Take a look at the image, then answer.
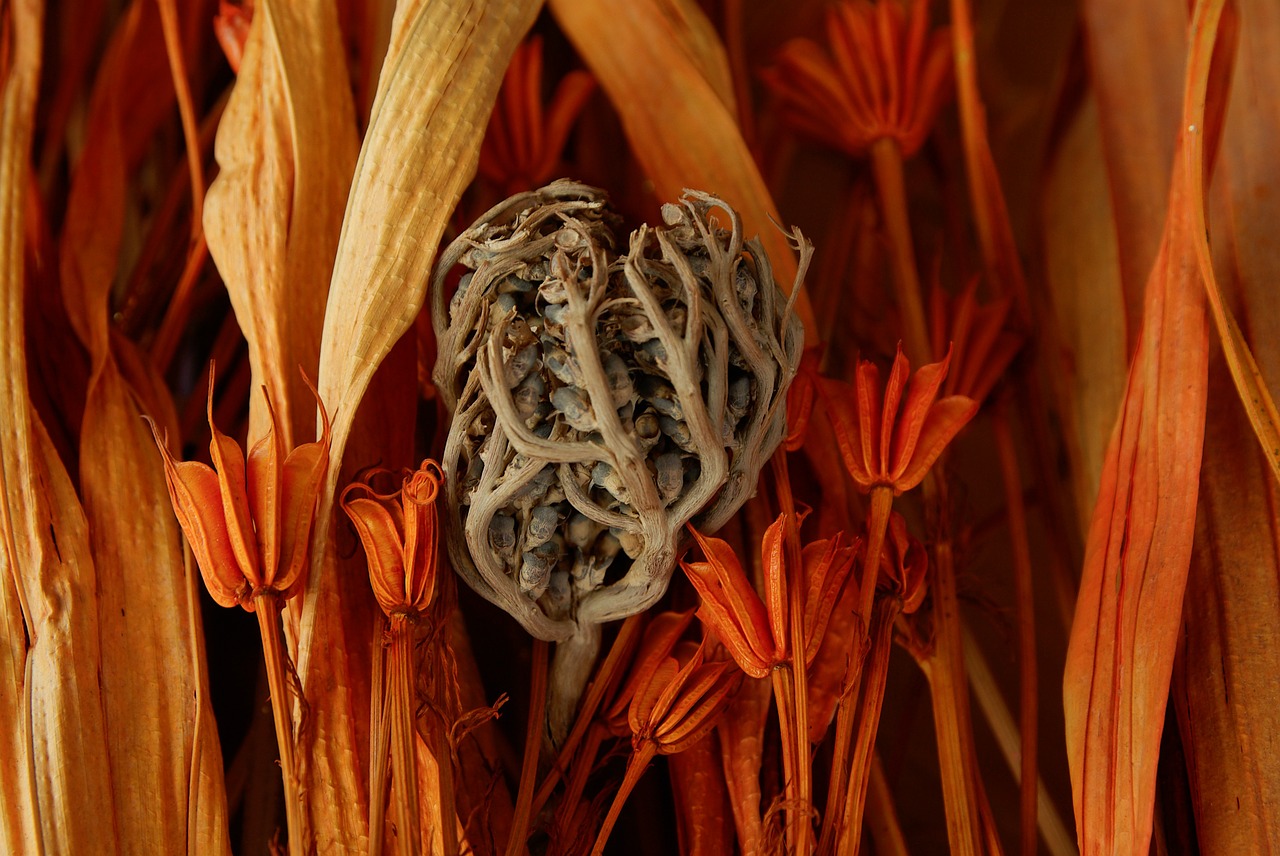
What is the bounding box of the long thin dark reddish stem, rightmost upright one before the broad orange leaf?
[992,398,1039,856]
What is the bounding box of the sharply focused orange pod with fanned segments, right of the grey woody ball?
[819,344,978,496]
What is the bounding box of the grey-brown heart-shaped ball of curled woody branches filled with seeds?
[433,182,808,640]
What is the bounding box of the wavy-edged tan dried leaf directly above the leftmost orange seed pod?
[204,0,356,448]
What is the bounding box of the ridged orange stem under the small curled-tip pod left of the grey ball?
[387,614,422,853]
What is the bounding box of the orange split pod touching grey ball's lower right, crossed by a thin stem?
[681,514,855,678]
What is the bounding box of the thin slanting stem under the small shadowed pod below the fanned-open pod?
[837,598,901,855]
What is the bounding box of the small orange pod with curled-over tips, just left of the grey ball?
[342,459,444,615]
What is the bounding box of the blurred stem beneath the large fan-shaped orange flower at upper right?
[868,137,932,365]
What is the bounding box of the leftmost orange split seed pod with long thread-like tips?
[151,372,329,612]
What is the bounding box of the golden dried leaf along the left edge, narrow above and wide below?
[0,0,119,853]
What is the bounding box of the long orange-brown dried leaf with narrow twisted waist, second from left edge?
[50,3,229,853]
